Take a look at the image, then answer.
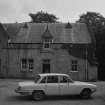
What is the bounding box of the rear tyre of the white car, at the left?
[32,91,45,101]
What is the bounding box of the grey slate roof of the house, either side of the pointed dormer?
[3,23,91,44]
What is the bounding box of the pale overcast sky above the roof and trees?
[0,0,105,23]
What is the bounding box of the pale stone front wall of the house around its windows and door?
[1,44,97,81]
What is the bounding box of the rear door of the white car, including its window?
[46,76,60,95]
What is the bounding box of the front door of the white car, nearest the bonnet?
[59,76,75,95]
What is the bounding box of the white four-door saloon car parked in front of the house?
[15,73,96,100]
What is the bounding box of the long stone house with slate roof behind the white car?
[0,23,97,81]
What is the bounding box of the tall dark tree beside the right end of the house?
[77,12,105,79]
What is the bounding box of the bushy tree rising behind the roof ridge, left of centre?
[29,11,58,23]
